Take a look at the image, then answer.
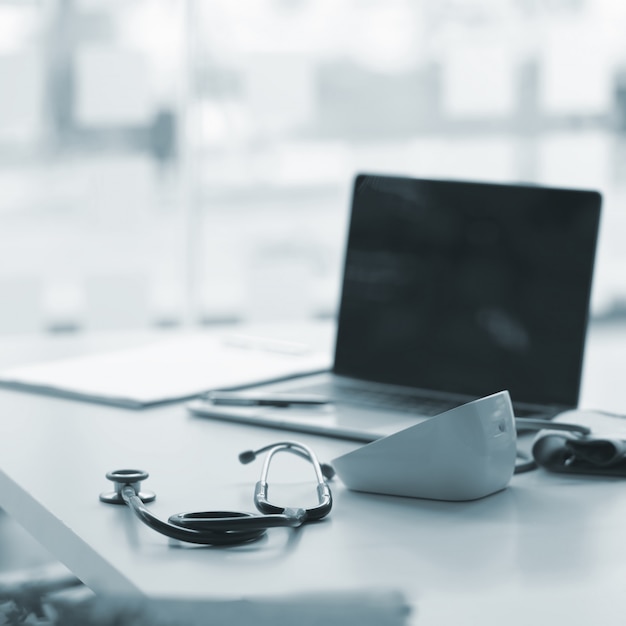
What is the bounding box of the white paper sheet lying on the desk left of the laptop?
[0,334,332,408]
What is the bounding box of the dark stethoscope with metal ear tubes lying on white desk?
[100,441,335,545]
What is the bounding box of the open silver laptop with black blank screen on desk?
[189,174,601,441]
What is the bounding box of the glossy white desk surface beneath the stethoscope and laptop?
[0,320,626,626]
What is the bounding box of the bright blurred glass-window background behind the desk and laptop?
[0,0,626,333]
